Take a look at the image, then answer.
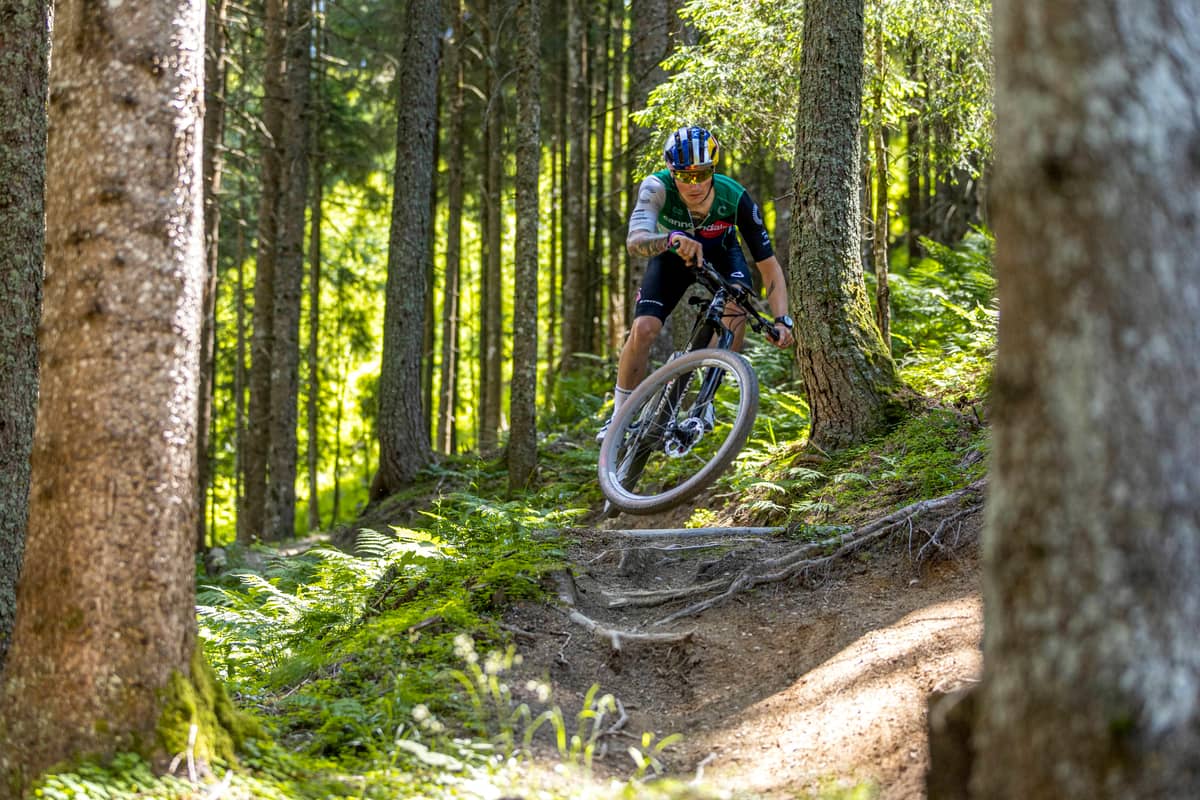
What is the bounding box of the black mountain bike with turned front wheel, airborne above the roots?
[599,261,779,515]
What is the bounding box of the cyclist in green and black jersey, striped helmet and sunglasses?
[596,125,792,441]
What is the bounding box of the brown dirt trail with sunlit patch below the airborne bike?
[508,496,982,800]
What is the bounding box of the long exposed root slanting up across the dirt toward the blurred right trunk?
[638,479,986,625]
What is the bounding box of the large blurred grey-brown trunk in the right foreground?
[972,0,1200,800]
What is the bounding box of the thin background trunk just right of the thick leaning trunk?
[437,0,466,453]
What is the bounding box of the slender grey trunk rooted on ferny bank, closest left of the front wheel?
[509,0,541,491]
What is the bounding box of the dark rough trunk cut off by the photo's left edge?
[0,0,50,672]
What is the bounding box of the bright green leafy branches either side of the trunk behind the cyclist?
[638,0,992,169]
